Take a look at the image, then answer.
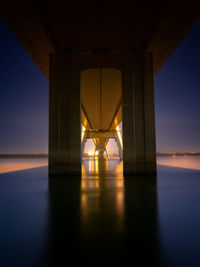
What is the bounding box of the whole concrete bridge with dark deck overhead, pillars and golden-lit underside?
[1,0,199,175]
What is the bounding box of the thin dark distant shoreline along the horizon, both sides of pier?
[0,152,200,159]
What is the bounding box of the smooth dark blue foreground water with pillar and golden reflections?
[0,160,200,267]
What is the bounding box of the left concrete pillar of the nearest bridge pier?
[49,53,81,175]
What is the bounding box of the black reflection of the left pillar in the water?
[47,177,81,266]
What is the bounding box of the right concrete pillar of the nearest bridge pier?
[122,51,156,175]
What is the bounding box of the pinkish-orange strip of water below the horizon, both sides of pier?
[0,156,200,173]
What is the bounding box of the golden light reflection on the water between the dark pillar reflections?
[81,158,124,231]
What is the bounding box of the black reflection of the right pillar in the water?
[124,175,161,266]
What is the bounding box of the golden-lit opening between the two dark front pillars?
[81,68,123,169]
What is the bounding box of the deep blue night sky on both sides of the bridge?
[0,19,200,153]
